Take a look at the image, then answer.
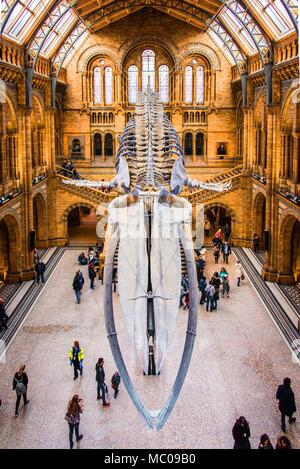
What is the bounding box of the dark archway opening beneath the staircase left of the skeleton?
[66,204,97,244]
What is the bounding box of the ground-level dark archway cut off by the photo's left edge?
[0,215,21,281]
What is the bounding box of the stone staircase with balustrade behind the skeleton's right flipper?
[182,165,243,204]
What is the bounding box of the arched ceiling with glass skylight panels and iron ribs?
[1,0,298,75]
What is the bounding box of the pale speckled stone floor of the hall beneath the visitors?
[0,250,300,448]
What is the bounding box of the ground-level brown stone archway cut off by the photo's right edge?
[279,214,300,284]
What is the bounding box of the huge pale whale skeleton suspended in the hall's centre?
[65,86,230,428]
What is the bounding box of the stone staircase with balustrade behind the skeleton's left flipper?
[56,166,118,204]
